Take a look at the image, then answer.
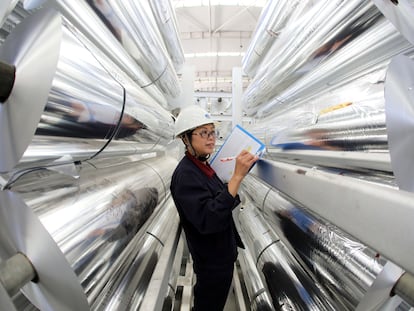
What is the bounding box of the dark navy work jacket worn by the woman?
[170,156,243,268]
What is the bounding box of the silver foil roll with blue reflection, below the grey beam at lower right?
[243,176,385,310]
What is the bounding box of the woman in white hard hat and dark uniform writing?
[170,105,258,311]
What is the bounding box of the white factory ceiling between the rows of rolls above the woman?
[172,0,266,93]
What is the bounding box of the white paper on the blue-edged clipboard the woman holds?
[210,125,265,182]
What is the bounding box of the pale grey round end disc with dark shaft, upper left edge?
[0,7,60,172]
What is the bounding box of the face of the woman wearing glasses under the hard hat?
[191,124,216,156]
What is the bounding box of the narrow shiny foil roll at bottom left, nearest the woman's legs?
[91,198,179,311]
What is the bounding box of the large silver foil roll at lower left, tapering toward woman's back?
[8,156,178,304]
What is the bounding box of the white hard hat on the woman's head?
[175,105,214,137]
